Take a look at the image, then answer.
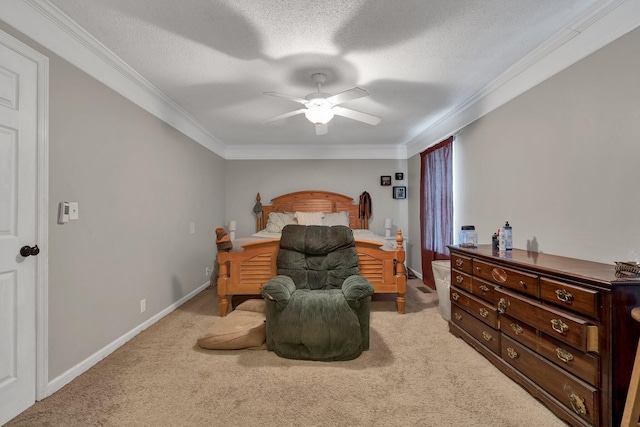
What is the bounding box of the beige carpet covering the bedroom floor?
[7,280,565,427]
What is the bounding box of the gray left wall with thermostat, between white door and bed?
[0,22,225,380]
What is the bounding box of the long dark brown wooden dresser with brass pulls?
[449,245,640,426]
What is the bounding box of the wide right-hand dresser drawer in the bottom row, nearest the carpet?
[500,336,600,425]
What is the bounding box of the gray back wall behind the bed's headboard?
[221,160,414,241]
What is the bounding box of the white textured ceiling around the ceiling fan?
[51,0,603,154]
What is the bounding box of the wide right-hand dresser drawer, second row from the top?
[496,289,598,352]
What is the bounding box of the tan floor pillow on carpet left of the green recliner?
[198,300,266,350]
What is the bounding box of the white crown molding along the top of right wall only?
[406,0,640,157]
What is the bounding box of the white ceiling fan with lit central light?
[264,73,381,135]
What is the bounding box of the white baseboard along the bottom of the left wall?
[42,282,209,399]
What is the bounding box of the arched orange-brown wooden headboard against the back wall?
[256,190,369,231]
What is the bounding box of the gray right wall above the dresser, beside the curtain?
[409,25,640,270]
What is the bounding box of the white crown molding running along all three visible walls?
[0,0,640,159]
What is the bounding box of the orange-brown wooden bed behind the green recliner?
[216,190,407,316]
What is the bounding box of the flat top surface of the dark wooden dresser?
[449,245,640,287]
